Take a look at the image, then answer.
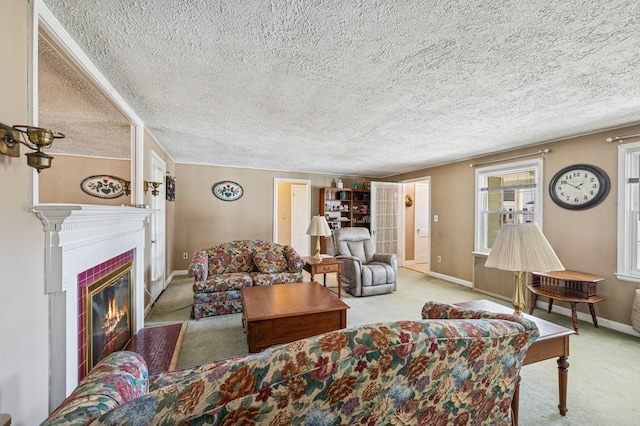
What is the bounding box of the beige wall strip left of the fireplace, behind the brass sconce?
[0,0,50,426]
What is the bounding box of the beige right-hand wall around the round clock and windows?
[389,126,640,324]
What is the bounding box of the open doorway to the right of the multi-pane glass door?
[403,177,431,274]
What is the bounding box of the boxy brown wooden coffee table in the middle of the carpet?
[240,281,349,352]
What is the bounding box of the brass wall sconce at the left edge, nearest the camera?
[0,123,64,173]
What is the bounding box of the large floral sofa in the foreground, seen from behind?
[42,302,538,426]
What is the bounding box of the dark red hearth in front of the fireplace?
[126,322,187,374]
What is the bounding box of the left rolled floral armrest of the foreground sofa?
[41,351,149,426]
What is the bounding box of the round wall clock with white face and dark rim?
[549,164,611,210]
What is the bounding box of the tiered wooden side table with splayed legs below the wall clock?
[527,271,604,334]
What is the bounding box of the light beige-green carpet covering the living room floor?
[146,268,640,426]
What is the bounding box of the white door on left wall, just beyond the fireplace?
[147,152,167,301]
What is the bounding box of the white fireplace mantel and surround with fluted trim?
[33,204,152,409]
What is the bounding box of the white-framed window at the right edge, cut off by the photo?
[616,142,640,282]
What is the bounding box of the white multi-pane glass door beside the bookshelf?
[371,182,402,254]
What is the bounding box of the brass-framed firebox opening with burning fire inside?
[85,263,133,374]
